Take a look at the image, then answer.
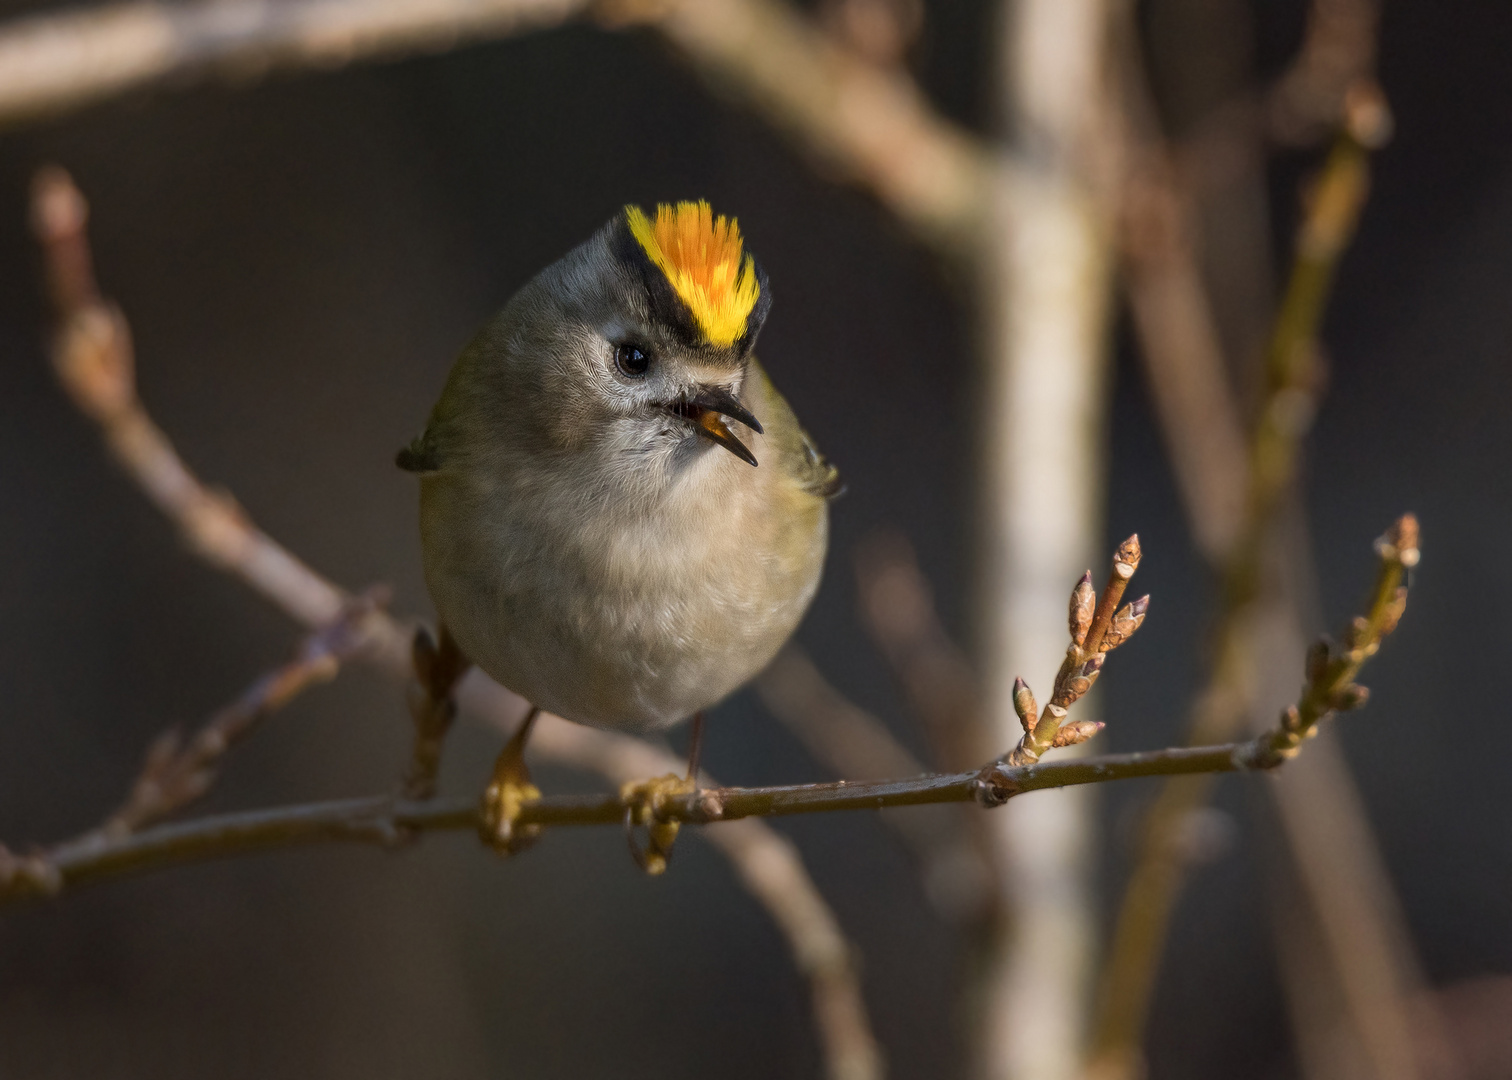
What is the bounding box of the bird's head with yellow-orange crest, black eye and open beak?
[489,203,771,466]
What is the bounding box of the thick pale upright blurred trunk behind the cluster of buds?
[971,0,1117,1080]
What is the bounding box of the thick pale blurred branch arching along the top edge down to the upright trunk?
[0,0,998,251]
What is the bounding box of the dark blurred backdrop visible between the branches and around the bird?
[0,0,1512,1080]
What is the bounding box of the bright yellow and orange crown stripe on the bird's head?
[624,201,761,348]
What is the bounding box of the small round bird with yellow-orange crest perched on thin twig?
[398,201,841,873]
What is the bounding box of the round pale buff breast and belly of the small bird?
[422,420,827,731]
